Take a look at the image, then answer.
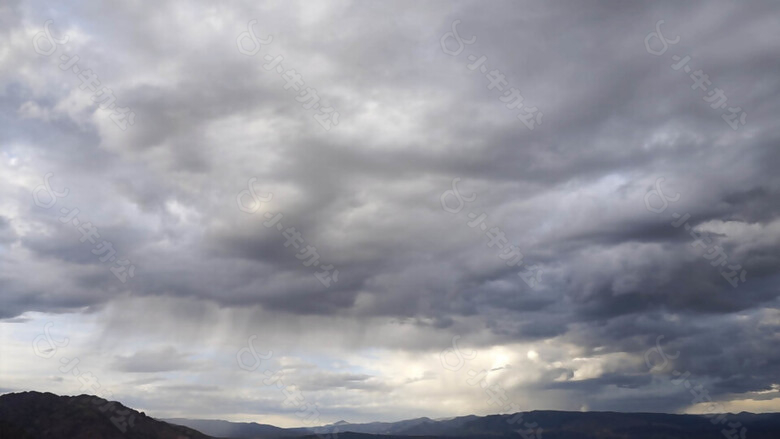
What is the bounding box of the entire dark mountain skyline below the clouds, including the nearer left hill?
[0,392,780,439]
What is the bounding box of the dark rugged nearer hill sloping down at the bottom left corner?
[0,392,209,439]
